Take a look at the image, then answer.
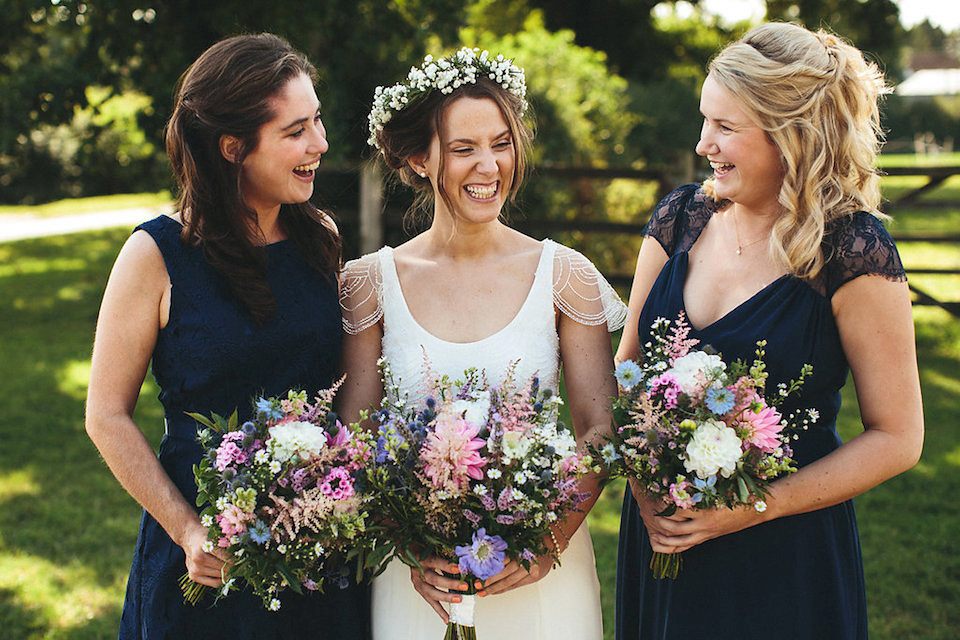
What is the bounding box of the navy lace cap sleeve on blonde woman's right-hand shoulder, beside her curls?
[823,211,907,297]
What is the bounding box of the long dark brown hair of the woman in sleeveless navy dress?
[166,33,340,323]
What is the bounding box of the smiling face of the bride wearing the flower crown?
[411,97,516,224]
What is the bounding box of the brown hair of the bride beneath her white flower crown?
[377,77,533,229]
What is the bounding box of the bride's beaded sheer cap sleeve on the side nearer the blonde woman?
[553,245,627,331]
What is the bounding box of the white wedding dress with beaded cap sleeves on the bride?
[341,240,627,640]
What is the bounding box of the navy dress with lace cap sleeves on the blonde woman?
[616,185,905,640]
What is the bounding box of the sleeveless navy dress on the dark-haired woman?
[119,216,370,640]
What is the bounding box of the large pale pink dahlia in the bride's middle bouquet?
[420,419,487,492]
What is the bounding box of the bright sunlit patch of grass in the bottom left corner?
[0,554,124,635]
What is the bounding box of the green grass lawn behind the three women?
[0,185,960,640]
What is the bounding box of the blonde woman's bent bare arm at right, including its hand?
[641,276,923,552]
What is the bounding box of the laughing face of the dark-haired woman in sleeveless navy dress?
[236,75,329,214]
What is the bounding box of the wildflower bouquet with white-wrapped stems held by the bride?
[370,361,592,639]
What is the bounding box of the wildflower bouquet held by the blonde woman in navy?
[591,312,818,578]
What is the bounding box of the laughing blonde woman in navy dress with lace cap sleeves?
[617,23,923,640]
